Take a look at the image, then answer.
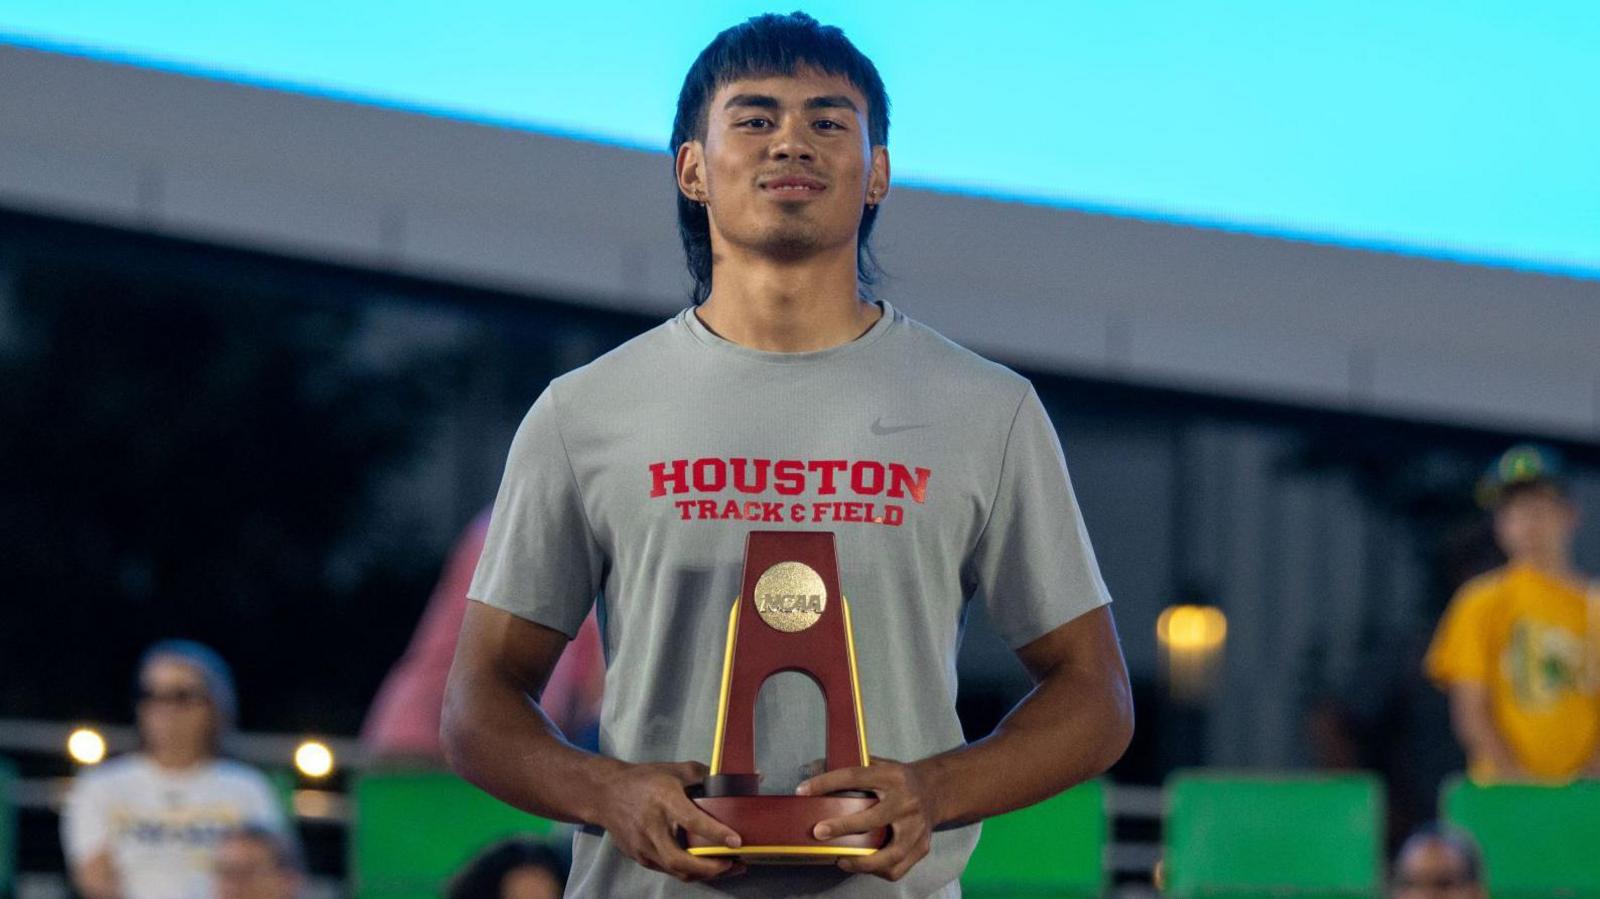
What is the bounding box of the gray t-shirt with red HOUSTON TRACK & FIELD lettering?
[467,302,1110,899]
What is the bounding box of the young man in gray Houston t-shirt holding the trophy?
[443,13,1133,897]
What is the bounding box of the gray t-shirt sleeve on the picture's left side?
[467,386,605,638]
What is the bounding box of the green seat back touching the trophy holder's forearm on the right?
[962,781,1109,899]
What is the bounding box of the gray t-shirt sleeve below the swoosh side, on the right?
[966,387,1110,649]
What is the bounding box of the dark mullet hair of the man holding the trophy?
[669,13,890,306]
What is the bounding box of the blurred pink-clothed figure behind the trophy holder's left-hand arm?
[362,510,605,766]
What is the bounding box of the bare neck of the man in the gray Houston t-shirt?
[696,242,882,352]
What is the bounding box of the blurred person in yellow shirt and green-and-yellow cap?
[1424,445,1600,782]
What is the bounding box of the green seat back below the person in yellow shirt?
[1440,777,1600,899]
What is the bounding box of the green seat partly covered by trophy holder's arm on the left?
[350,771,552,899]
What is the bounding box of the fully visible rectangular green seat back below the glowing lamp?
[1163,771,1384,897]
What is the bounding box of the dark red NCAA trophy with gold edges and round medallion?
[688,531,886,864]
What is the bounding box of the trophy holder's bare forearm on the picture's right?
[914,655,1133,824]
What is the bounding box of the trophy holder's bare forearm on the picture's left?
[442,665,626,824]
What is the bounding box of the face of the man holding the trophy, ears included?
[678,69,888,268]
